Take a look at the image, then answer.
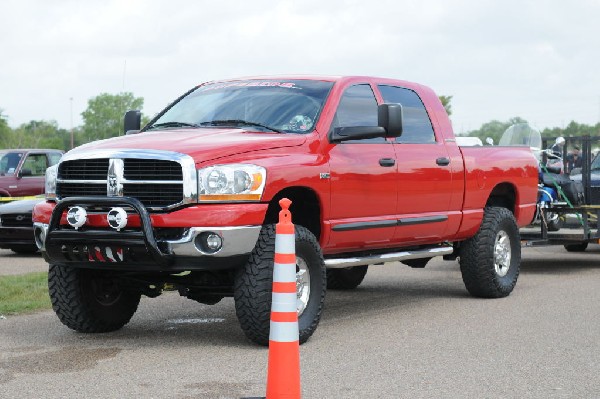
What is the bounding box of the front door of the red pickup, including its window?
[328,84,397,249]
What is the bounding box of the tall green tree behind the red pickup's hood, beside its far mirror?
[81,92,144,142]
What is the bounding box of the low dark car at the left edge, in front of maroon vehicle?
[0,197,44,254]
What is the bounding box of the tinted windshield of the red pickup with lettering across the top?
[145,80,333,133]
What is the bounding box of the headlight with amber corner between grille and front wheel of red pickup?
[198,164,267,202]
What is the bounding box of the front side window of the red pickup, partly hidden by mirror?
[332,84,386,143]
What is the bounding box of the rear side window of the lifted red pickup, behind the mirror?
[378,85,435,144]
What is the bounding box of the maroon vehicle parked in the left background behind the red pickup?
[0,149,63,197]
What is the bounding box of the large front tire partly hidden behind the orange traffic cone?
[234,225,326,346]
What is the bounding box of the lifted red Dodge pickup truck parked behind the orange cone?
[34,76,538,344]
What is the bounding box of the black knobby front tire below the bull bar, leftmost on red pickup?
[48,265,141,333]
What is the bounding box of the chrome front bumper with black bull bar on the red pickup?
[34,197,261,271]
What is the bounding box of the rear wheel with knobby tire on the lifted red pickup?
[460,207,521,298]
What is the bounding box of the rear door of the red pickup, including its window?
[378,85,462,244]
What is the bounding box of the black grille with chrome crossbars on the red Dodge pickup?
[56,158,184,209]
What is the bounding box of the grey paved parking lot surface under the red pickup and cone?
[0,246,600,399]
